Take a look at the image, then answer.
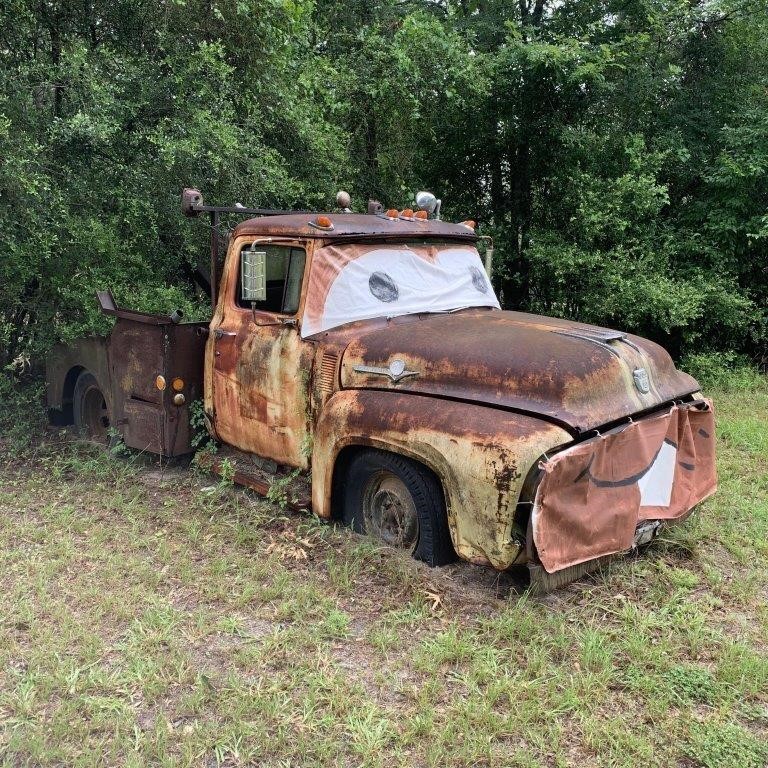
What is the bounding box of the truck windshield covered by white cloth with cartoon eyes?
[301,242,500,336]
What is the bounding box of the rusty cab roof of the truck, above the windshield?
[234,213,477,242]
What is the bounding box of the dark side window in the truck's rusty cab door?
[237,248,307,315]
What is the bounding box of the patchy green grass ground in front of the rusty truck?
[0,383,768,768]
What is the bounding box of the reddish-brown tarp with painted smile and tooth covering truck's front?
[531,400,717,573]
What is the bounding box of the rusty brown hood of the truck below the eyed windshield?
[340,309,699,432]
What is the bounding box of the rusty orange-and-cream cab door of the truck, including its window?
[206,240,312,468]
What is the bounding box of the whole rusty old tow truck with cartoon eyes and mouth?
[47,190,716,589]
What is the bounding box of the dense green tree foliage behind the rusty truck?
[0,0,768,365]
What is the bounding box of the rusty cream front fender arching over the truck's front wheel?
[312,390,571,569]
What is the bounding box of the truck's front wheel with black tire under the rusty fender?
[342,449,456,566]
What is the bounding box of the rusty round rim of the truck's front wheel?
[363,471,419,552]
